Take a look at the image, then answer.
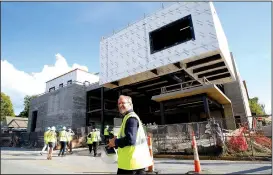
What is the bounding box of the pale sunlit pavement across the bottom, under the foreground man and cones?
[1,148,272,174]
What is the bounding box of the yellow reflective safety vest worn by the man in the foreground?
[118,112,152,170]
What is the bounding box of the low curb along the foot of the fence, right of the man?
[154,154,272,161]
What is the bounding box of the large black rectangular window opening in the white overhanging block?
[149,15,195,54]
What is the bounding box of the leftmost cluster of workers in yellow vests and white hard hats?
[40,126,75,160]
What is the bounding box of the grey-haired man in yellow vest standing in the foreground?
[108,95,152,174]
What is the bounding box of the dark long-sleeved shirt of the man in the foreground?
[115,110,139,148]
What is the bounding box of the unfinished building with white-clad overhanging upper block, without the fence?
[28,2,251,132]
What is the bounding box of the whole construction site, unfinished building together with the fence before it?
[2,2,272,173]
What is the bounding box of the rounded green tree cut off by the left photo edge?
[1,92,15,120]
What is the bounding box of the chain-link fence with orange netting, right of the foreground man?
[146,119,272,157]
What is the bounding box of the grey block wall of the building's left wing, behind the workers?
[28,84,86,132]
